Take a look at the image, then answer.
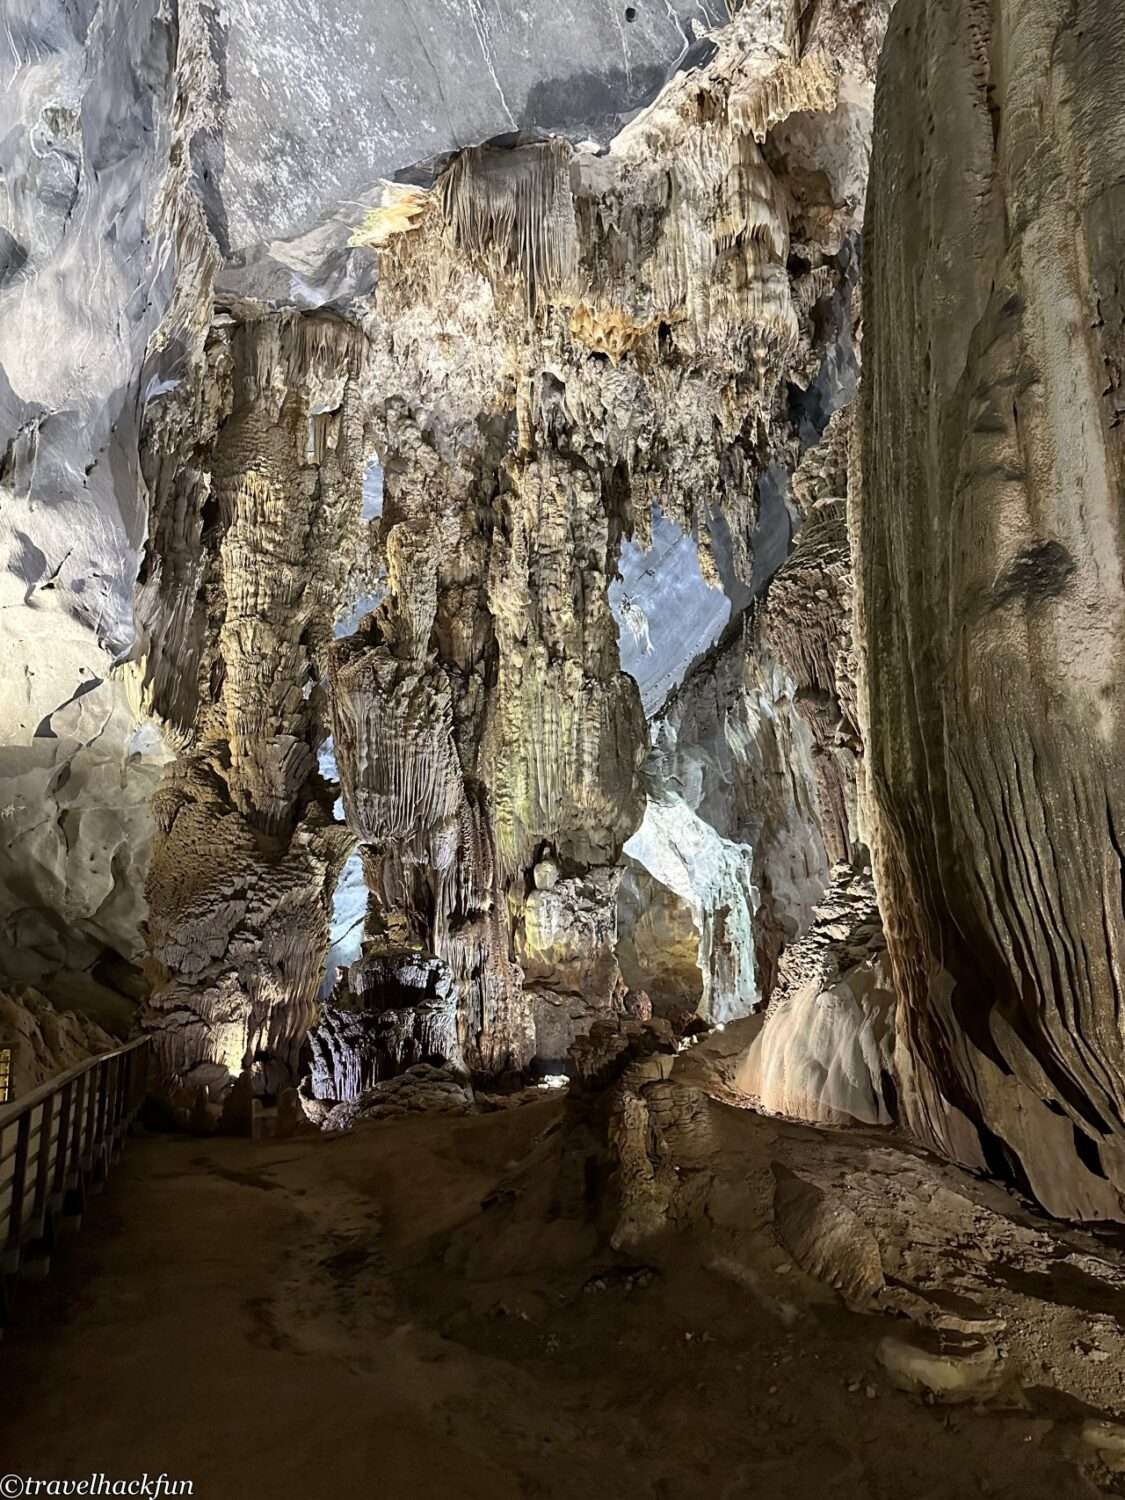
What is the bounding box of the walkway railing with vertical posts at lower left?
[0,1037,149,1284]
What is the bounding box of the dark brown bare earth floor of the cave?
[0,1100,1100,1500]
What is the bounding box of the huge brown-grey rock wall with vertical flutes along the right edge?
[852,0,1125,1218]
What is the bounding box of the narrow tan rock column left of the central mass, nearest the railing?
[138,317,365,1088]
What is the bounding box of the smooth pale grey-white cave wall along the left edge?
[0,0,218,1010]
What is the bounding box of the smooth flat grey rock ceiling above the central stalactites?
[213,0,726,255]
